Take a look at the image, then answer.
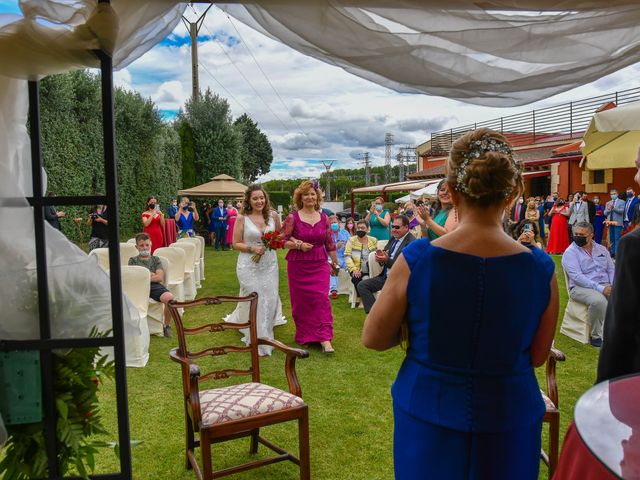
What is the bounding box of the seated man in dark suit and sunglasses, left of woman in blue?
[357,215,416,313]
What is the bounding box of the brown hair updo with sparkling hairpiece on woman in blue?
[446,128,524,206]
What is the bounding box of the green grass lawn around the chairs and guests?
[96,247,598,480]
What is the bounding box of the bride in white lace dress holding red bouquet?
[224,185,286,355]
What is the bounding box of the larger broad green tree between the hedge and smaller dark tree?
[179,88,242,183]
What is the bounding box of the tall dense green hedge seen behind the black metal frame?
[40,70,182,241]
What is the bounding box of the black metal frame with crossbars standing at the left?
[0,21,132,480]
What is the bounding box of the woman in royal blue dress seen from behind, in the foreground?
[363,129,558,480]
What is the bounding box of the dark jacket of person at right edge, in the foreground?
[597,230,640,382]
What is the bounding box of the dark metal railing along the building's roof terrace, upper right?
[427,87,640,156]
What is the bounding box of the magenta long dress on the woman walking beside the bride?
[282,212,336,344]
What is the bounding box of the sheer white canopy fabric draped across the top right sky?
[224,0,640,107]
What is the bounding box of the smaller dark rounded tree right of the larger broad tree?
[234,113,273,182]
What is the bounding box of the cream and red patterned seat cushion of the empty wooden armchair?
[200,383,304,426]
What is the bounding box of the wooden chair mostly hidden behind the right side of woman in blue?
[540,347,565,479]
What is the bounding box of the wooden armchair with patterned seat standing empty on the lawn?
[169,293,310,480]
